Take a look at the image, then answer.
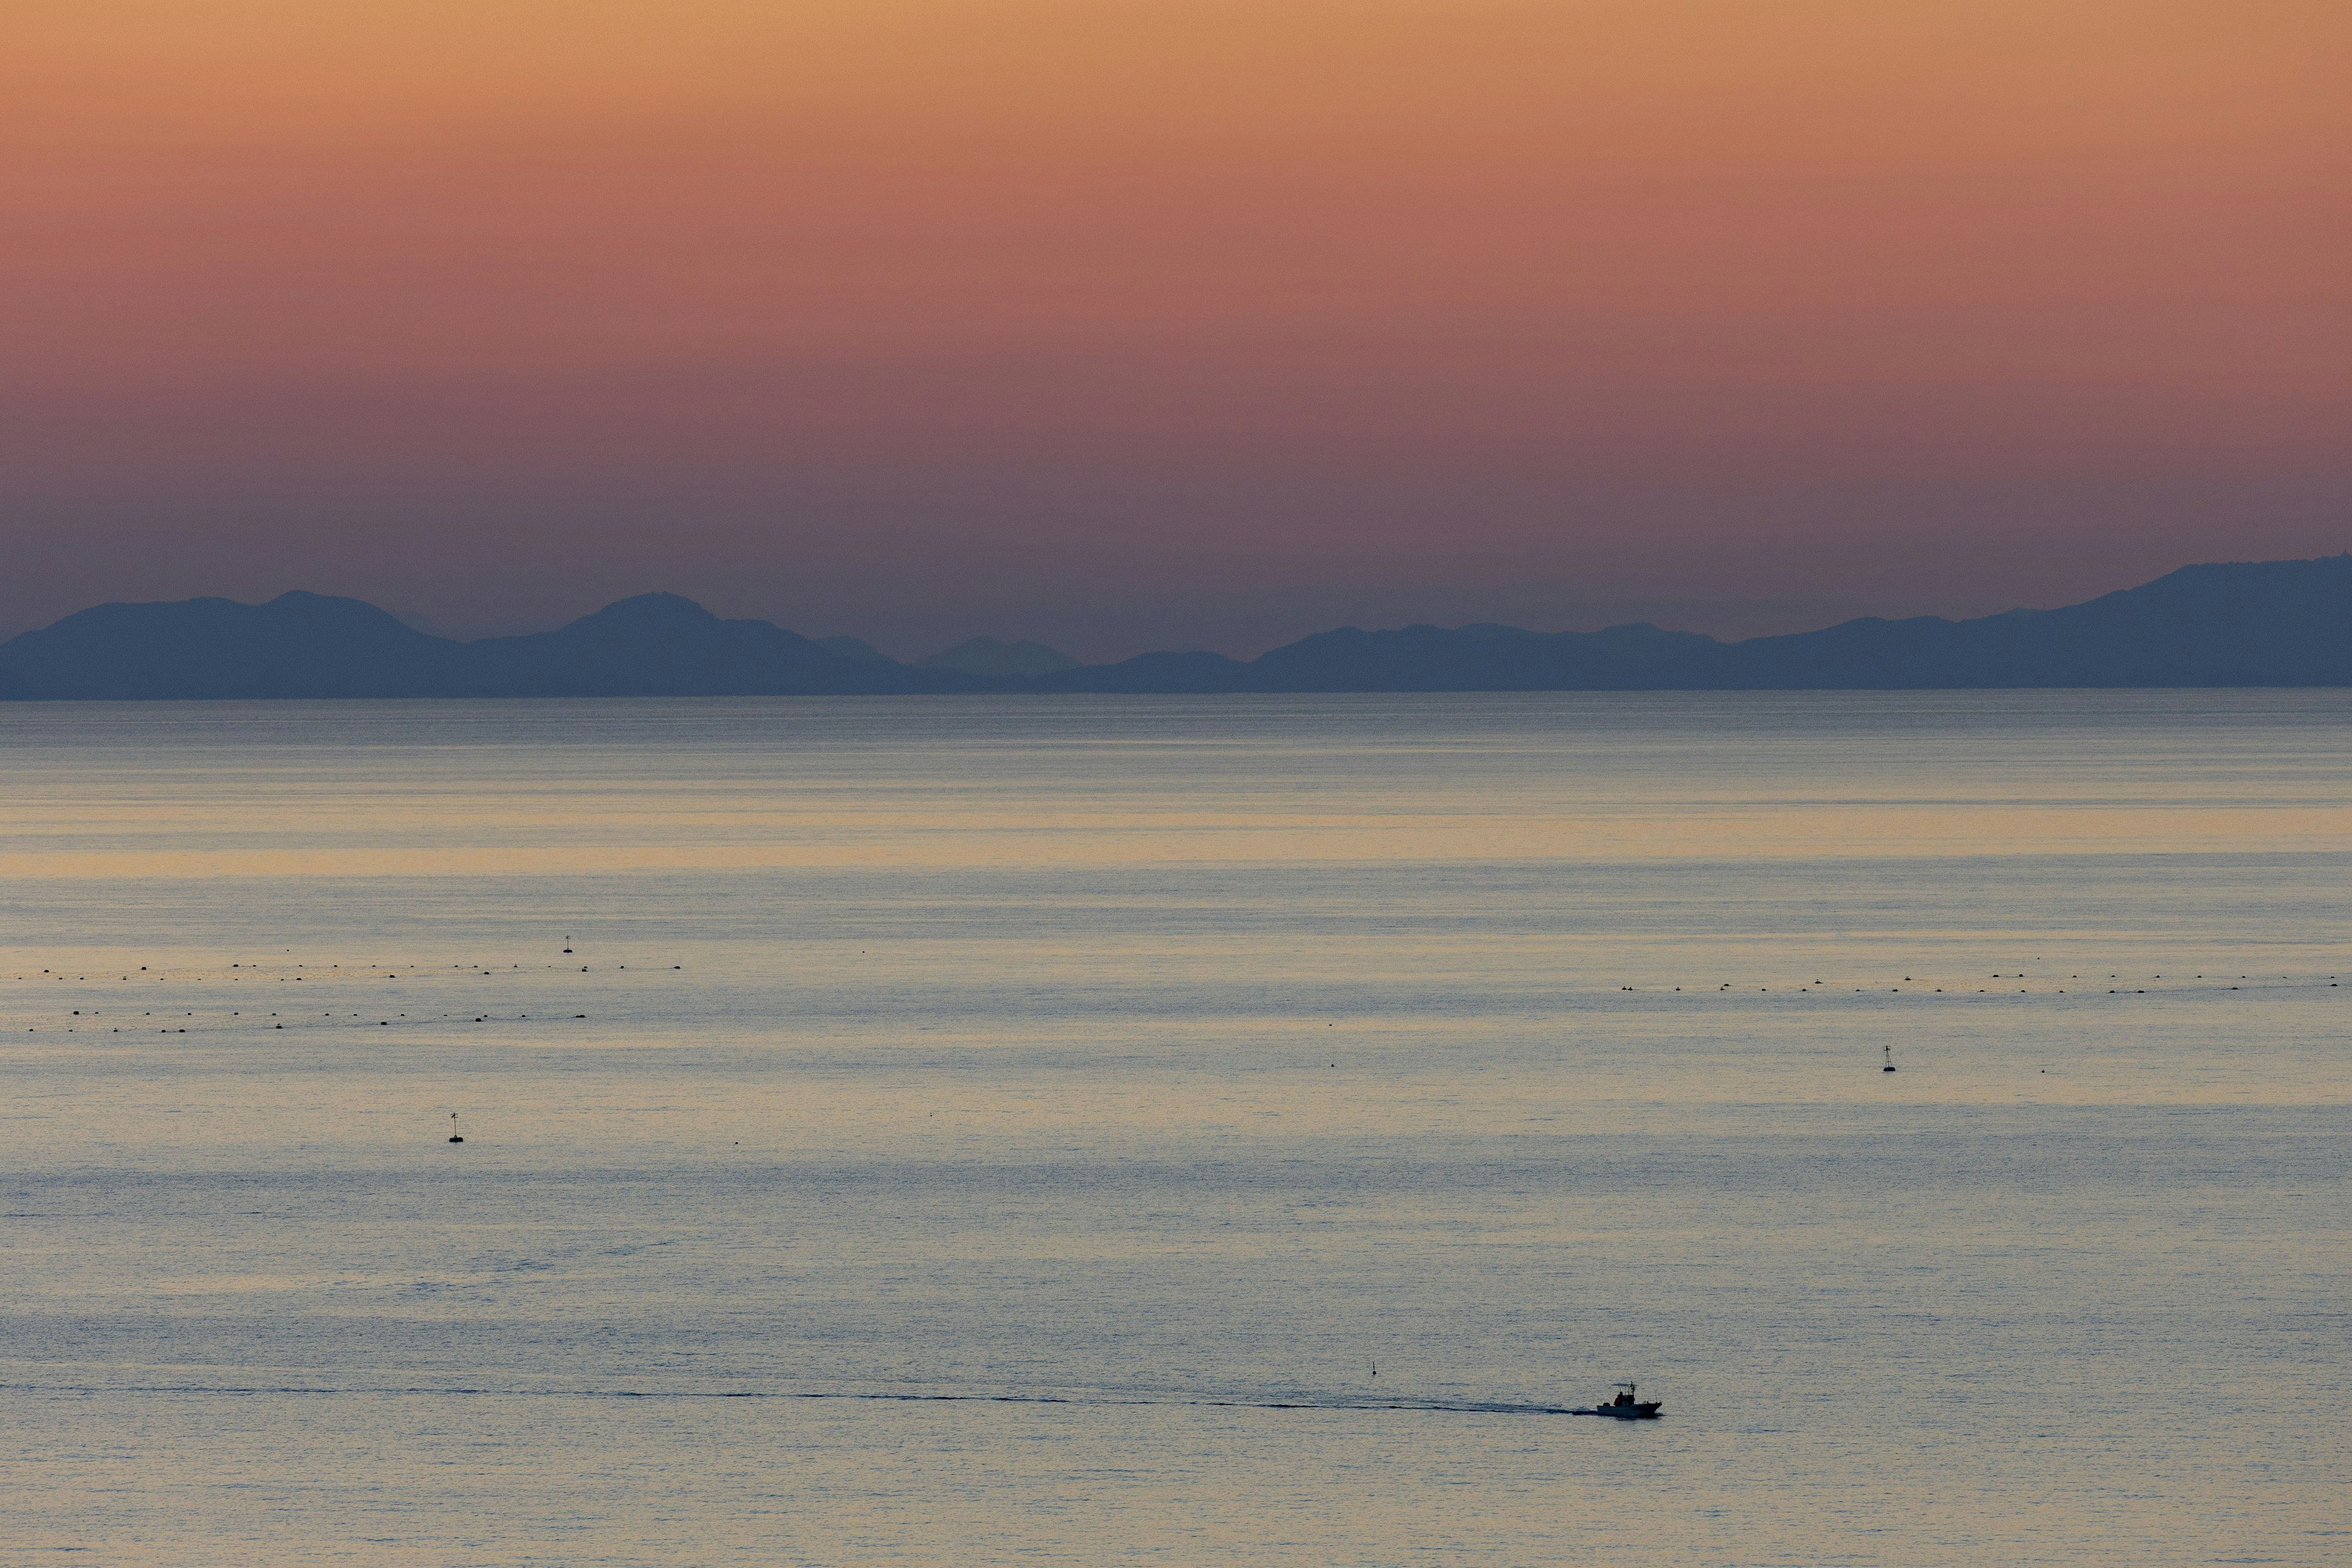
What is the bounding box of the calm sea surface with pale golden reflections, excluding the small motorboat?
[0,691,2352,1568]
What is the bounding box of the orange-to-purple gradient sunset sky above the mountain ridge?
[0,0,2352,658]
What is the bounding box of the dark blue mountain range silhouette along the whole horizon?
[0,555,2352,698]
